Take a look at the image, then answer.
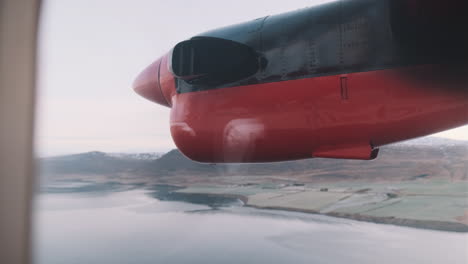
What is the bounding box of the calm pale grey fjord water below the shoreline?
[34,183,468,264]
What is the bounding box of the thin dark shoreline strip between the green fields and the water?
[176,189,468,233]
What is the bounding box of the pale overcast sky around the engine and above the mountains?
[36,0,468,156]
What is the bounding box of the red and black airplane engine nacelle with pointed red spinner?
[134,0,468,162]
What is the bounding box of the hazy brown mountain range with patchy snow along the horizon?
[41,138,468,181]
